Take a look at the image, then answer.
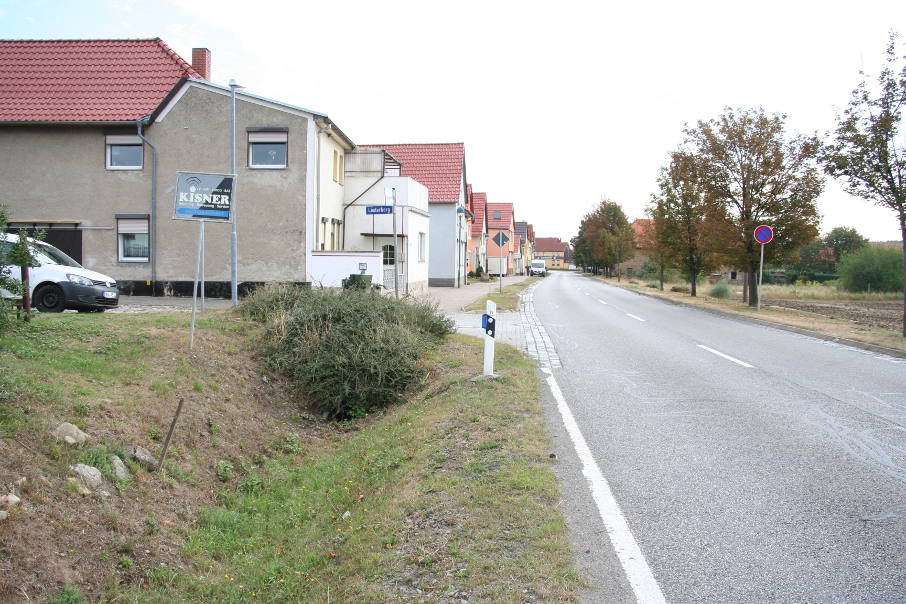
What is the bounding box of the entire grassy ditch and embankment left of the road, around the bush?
[0,313,580,602]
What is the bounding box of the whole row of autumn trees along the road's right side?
[572,33,906,336]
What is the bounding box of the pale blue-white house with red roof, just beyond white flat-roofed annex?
[360,143,471,287]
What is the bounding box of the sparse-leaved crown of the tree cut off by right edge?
[822,33,906,337]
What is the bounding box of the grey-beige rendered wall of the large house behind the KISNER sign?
[0,85,311,294]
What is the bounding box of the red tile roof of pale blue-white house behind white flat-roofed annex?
[359,143,466,203]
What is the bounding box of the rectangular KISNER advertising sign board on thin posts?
[173,172,235,222]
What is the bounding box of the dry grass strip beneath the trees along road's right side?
[589,275,906,351]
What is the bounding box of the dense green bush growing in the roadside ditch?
[241,286,453,419]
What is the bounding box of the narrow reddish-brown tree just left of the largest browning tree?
[655,151,722,296]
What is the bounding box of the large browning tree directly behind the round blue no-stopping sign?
[685,108,824,306]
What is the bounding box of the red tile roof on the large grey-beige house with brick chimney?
[0,38,201,122]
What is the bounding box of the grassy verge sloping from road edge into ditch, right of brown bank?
[116,336,580,602]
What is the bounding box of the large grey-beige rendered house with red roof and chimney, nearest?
[0,38,353,296]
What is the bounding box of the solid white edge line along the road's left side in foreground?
[541,368,667,604]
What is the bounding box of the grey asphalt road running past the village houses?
[530,272,906,602]
